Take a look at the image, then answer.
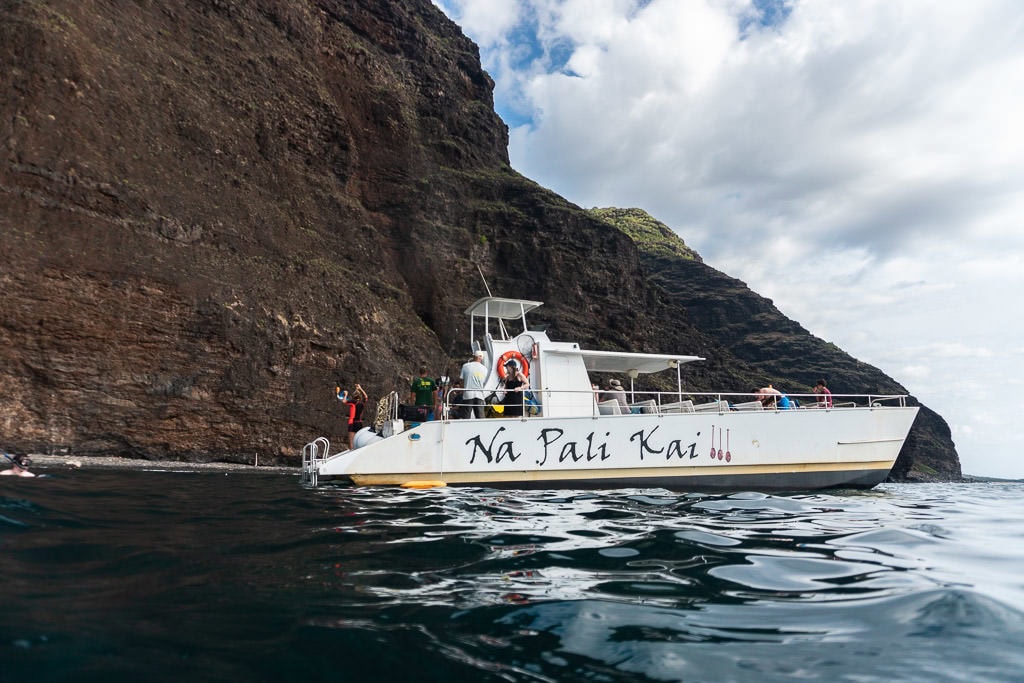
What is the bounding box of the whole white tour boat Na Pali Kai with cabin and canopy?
[302,297,918,490]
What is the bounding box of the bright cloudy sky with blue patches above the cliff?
[434,0,1024,478]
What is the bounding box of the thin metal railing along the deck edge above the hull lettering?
[440,389,907,420]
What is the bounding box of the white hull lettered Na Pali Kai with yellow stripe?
[316,408,918,490]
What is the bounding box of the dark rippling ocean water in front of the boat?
[0,470,1024,683]
